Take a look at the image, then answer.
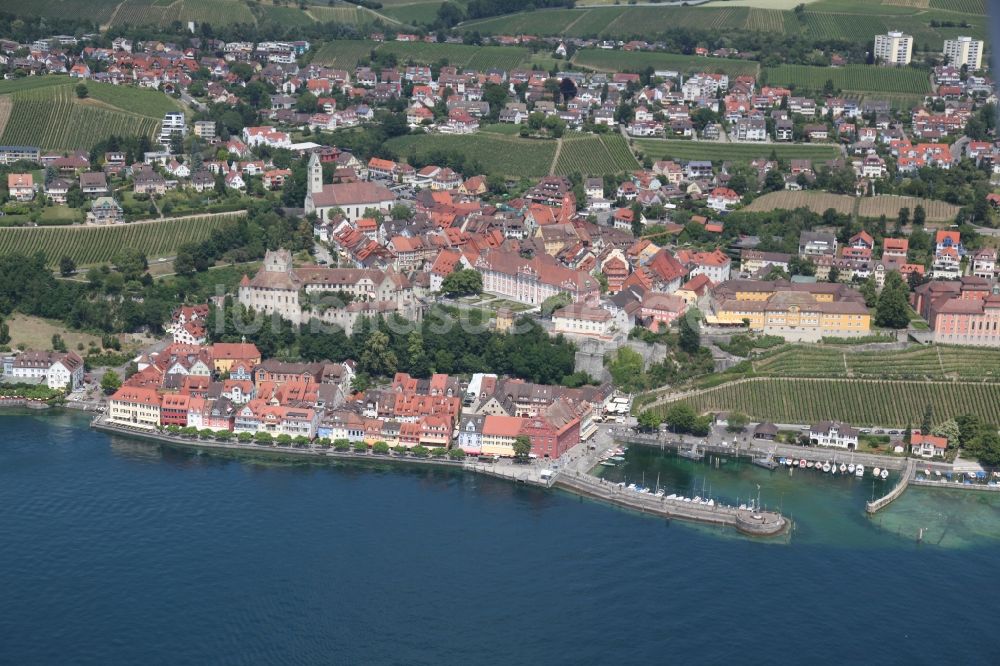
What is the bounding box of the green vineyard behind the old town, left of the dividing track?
[386,133,556,177]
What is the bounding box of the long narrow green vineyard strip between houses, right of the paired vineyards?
[632,139,840,162]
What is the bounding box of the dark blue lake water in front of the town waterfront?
[0,414,1000,664]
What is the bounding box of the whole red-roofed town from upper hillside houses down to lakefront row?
[0,18,1000,472]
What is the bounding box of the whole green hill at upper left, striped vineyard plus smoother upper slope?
[0,77,179,150]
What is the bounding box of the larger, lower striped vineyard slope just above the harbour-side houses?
[654,377,1000,428]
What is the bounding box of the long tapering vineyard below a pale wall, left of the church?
[0,211,243,266]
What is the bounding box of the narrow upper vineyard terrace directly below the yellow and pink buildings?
[753,345,1000,382]
